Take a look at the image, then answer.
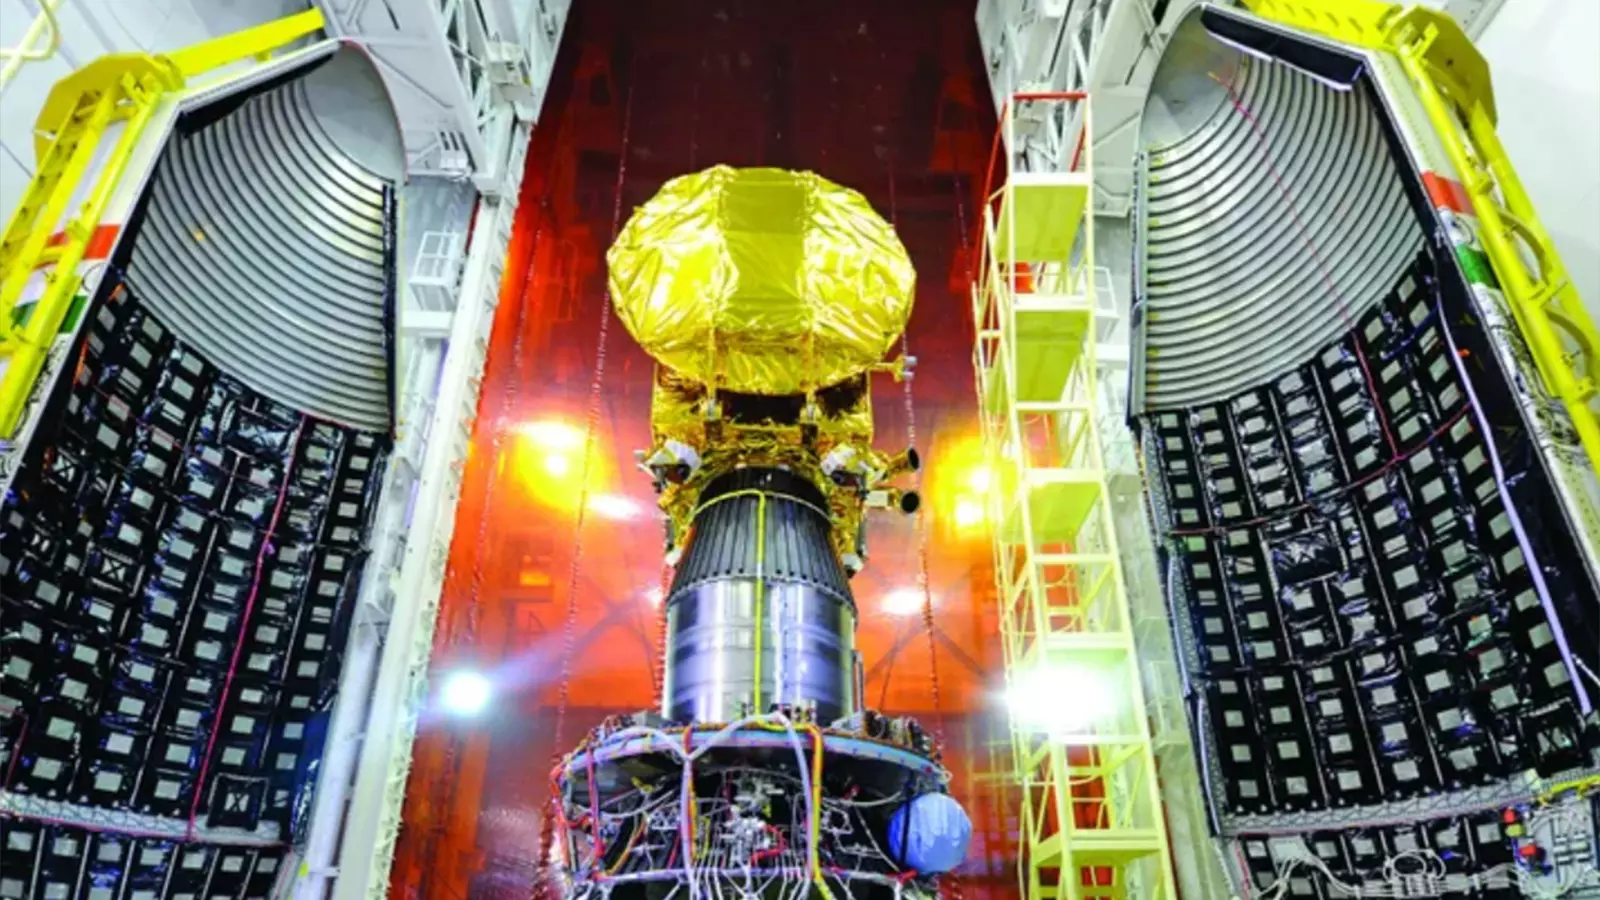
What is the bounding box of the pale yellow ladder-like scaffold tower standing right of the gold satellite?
[971,94,1178,900]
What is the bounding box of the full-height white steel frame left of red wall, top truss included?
[293,0,571,900]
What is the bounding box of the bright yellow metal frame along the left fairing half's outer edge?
[0,10,323,439]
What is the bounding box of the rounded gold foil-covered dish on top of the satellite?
[606,165,917,396]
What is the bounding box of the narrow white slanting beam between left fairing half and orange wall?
[312,123,530,900]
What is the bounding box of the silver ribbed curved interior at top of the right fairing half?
[1134,14,1422,412]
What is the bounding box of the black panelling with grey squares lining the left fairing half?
[0,290,389,852]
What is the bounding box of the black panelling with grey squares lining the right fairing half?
[1141,255,1595,815]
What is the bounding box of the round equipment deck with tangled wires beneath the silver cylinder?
[552,713,949,900]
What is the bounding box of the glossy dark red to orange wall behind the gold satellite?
[392,0,1014,898]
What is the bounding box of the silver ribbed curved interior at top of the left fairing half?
[128,50,403,431]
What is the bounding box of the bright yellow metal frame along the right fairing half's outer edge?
[1245,0,1600,471]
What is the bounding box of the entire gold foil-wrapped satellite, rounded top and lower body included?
[606,167,915,567]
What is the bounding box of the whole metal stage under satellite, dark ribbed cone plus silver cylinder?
[662,469,859,722]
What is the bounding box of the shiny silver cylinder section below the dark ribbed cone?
[662,578,858,722]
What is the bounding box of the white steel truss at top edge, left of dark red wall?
[317,0,571,197]
